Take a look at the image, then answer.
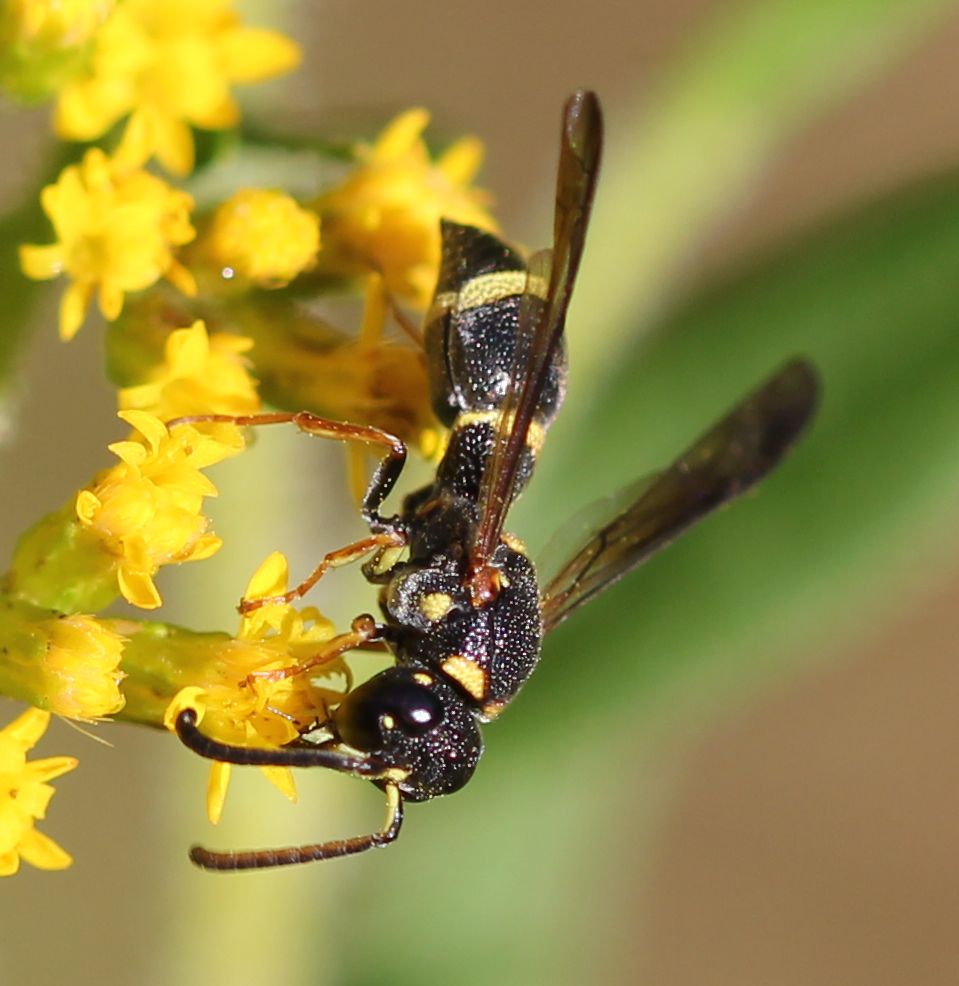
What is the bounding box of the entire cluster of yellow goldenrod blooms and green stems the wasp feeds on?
[0,0,506,875]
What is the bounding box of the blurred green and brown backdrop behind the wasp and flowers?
[0,0,959,986]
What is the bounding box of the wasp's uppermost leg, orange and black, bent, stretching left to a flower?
[167,411,406,533]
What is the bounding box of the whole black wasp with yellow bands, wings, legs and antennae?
[176,91,819,870]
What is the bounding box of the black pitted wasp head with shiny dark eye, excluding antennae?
[331,666,483,801]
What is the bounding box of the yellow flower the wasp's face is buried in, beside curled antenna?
[165,552,352,823]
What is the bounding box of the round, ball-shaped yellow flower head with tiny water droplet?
[207,188,320,287]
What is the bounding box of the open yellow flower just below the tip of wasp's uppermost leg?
[76,411,243,609]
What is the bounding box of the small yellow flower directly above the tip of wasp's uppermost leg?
[118,320,260,421]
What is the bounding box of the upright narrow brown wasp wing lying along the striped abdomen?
[470,90,603,570]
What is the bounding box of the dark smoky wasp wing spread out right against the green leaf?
[543,360,819,632]
